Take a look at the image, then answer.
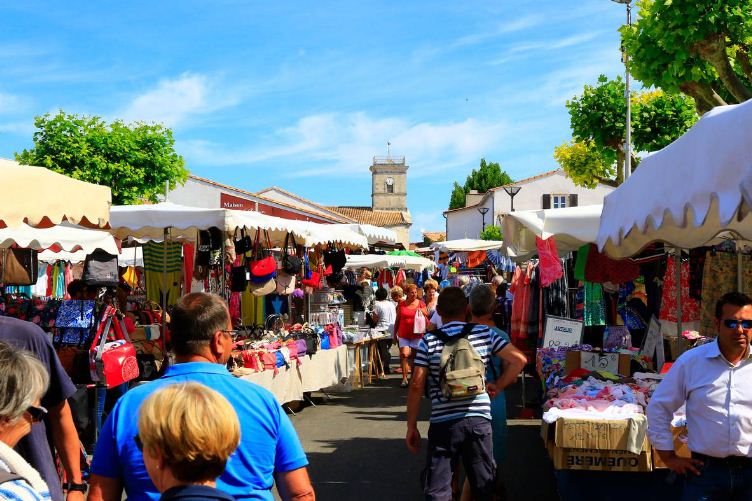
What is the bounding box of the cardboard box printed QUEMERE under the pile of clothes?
[541,418,653,472]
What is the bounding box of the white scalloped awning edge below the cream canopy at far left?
[0,222,120,254]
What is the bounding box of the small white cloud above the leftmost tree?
[116,73,238,127]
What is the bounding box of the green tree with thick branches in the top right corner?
[620,0,752,113]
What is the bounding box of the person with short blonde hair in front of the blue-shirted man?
[136,383,240,501]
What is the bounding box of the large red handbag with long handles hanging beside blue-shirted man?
[89,306,139,388]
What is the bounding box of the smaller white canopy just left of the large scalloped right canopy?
[502,205,603,259]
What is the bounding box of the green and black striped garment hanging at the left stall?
[143,242,183,306]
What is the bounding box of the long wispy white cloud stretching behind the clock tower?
[178,113,505,178]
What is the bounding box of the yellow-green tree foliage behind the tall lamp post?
[554,75,697,187]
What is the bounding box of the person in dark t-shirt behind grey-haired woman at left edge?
[0,317,86,501]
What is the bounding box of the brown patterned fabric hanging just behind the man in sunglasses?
[700,252,752,336]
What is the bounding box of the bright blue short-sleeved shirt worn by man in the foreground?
[91,362,308,501]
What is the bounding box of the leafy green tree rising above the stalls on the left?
[16,110,188,204]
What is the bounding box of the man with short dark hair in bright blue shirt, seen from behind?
[89,293,315,501]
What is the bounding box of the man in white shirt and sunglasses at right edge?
[647,292,752,500]
